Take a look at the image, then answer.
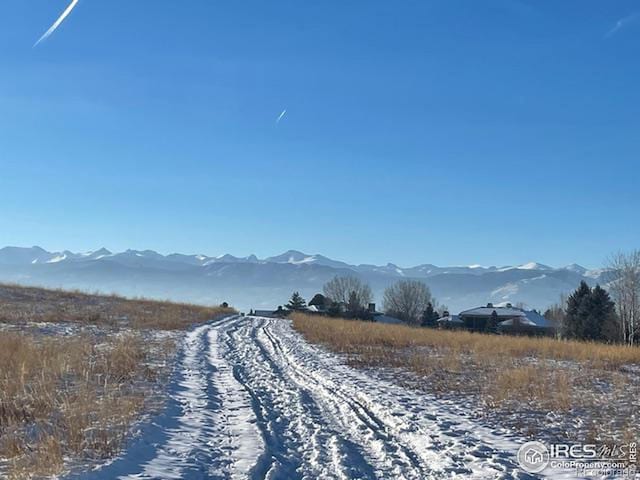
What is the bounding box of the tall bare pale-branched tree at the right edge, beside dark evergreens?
[607,250,640,345]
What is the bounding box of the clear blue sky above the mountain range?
[0,0,640,266]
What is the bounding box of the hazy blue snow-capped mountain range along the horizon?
[0,247,604,313]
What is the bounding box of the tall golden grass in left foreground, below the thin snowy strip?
[0,333,156,478]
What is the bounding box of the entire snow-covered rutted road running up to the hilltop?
[72,317,531,480]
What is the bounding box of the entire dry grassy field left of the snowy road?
[0,285,235,479]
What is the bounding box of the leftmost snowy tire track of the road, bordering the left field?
[74,317,263,480]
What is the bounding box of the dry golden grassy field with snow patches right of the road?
[293,314,640,441]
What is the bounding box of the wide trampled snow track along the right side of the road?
[255,320,531,478]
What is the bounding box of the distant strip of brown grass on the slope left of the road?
[0,284,233,330]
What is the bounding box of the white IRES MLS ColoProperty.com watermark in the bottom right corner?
[517,441,638,479]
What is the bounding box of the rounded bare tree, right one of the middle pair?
[384,280,433,325]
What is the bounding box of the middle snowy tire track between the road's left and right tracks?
[222,320,372,479]
